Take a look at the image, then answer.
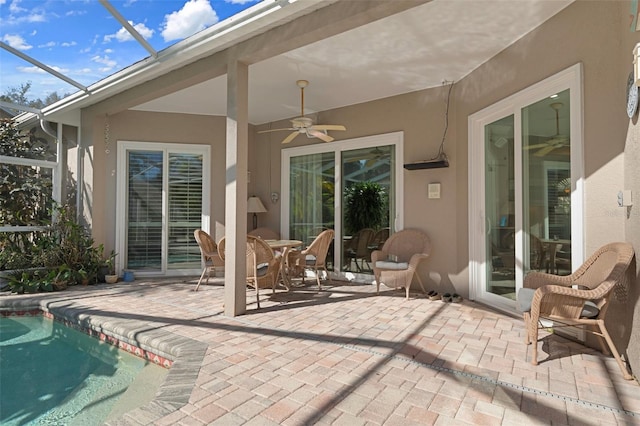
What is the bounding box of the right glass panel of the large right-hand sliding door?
[522,90,571,275]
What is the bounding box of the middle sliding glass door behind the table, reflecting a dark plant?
[282,133,402,280]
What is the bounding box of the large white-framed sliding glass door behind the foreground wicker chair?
[469,66,583,310]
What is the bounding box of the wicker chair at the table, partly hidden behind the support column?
[218,235,281,309]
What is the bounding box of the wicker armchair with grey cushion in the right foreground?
[517,243,634,380]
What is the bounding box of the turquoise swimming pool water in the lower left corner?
[0,316,167,426]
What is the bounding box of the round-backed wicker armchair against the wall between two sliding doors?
[371,229,431,299]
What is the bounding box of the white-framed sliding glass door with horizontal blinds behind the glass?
[117,142,209,275]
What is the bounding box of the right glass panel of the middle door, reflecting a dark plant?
[338,145,395,274]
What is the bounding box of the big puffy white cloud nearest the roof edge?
[162,0,219,41]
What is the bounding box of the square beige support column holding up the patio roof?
[224,58,249,317]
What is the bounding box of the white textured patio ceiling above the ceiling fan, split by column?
[132,0,573,124]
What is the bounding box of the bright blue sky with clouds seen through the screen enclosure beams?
[0,0,258,100]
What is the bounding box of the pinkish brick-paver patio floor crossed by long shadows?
[0,278,640,426]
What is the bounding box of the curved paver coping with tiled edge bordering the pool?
[0,293,208,425]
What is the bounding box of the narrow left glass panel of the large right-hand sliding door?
[484,115,516,298]
